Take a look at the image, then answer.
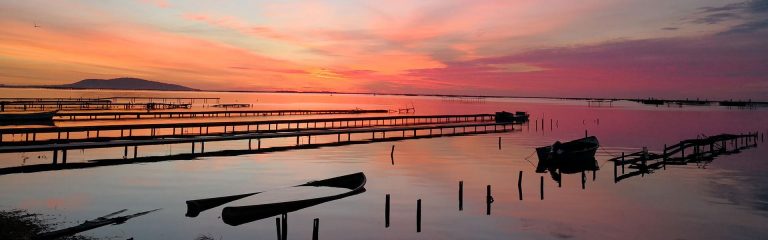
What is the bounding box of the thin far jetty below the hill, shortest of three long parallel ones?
[53,109,388,121]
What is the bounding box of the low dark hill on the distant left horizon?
[59,78,197,91]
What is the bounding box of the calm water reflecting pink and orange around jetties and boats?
[0,89,768,239]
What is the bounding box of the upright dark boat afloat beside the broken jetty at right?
[536,136,600,172]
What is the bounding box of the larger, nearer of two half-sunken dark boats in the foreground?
[221,172,366,226]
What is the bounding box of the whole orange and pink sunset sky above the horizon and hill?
[0,0,768,100]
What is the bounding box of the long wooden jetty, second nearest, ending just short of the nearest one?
[0,114,495,146]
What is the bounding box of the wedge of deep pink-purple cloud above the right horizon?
[410,31,768,99]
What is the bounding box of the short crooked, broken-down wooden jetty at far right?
[608,133,758,182]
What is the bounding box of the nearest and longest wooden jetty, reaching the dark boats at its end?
[0,117,521,175]
